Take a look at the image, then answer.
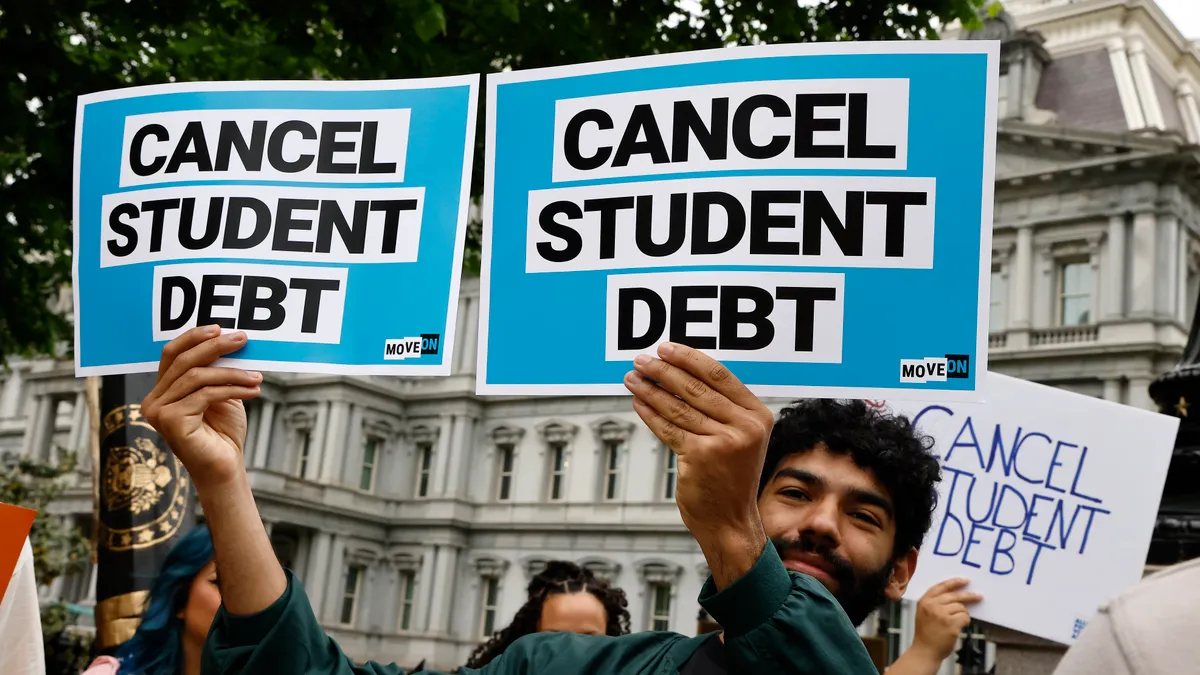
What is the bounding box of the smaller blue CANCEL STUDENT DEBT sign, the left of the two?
[74,76,479,376]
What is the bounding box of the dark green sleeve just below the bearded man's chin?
[700,544,878,675]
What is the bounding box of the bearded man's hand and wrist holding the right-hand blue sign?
[625,342,775,589]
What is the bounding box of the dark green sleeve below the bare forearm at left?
[200,572,463,675]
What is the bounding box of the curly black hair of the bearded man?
[758,399,942,558]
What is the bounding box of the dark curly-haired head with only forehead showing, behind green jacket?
[467,560,629,668]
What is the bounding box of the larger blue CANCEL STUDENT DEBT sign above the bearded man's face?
[478,41,998,400]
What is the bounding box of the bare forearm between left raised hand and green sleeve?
[197,473,287,615]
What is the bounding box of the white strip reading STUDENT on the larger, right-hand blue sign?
[526,177,935,273]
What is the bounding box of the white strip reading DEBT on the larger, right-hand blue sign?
[605,271,845,363]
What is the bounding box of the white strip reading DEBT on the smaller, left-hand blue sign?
[152,263,348,345]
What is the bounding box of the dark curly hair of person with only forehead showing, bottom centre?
[467,560,629,668]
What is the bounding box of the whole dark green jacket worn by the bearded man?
[200,544,877,675]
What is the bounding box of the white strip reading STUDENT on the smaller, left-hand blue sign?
[100,185,424,267]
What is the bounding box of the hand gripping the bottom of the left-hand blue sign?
[142,325,263,487]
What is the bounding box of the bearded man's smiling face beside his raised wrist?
[758,444,917,626]
